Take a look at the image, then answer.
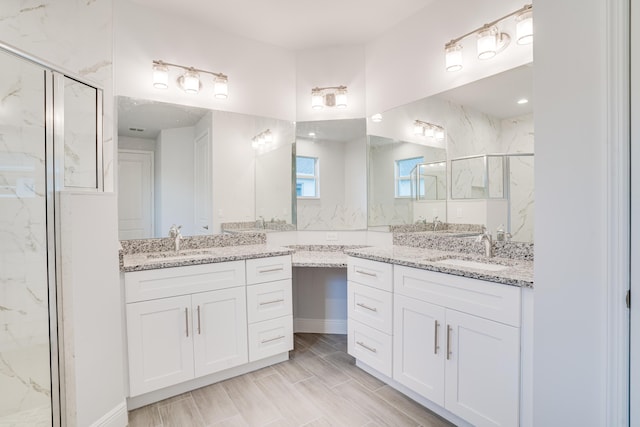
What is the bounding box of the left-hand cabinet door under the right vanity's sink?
[393,295,446,406]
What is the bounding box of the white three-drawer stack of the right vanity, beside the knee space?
[347,258,393,376]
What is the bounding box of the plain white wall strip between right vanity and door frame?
[533,0,608,426]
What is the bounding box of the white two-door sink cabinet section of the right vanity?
[393,266,521,426]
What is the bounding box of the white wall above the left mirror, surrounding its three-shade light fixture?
[115,0,296,120]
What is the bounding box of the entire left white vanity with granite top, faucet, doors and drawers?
[121,239,293,409]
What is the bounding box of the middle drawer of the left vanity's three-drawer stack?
[247,279,293,323]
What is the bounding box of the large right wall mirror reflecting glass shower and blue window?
[367,64,534,242]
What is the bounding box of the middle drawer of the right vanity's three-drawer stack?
[347,282,393,334]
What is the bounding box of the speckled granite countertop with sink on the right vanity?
[344,245,533,288]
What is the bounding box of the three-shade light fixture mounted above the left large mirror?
[152,59,229,99]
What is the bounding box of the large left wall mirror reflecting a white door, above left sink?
[118,96,295,239]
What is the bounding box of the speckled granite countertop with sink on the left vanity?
[120,244,294,272]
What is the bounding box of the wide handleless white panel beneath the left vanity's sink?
[124,261,245,303]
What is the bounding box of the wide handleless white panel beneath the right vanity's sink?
[393,266,521,326]
